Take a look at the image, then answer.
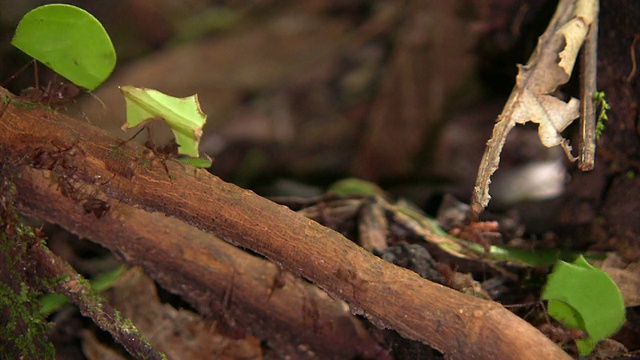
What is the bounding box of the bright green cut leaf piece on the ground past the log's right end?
[542,256,625,356]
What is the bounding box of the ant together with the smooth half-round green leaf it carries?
[5,4,116,116]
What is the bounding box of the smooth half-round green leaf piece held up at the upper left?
[11,4,116,90]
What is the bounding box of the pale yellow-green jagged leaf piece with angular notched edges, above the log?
[120,86,207,158]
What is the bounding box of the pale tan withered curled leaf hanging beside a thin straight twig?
[471,0,598,214]
